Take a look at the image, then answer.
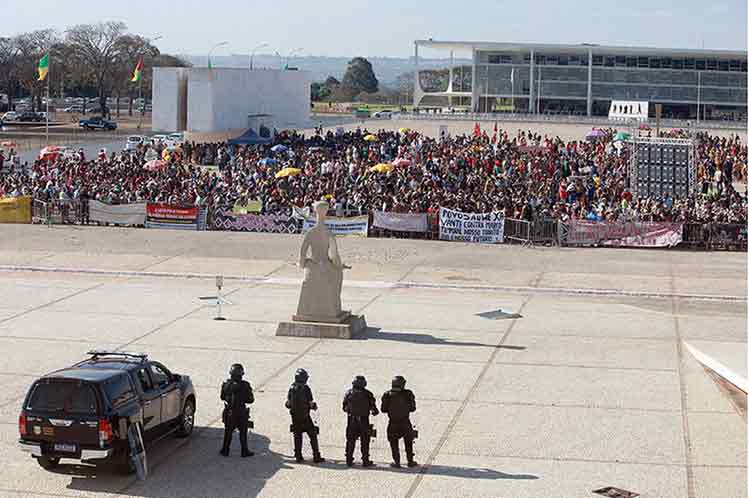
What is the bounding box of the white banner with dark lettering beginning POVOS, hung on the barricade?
[439,208,504,244]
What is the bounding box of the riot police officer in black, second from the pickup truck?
[286,368,325,463]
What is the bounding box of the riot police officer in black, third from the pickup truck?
[343,375,379,467]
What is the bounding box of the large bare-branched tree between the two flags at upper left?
[65,21,127,112]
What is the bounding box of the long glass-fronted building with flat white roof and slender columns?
[413,40,748,120]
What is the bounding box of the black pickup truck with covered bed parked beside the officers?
[18,351,196,472]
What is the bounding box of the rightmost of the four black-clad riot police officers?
[382,375,418,468]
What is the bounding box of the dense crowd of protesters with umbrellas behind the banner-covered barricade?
[0,124,748,223]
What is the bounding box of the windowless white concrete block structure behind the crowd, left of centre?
[153,68,311,133]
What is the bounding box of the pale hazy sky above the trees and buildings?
[0,0,748,57]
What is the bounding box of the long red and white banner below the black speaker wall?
[566,220,683,247]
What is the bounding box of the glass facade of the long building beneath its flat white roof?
[430,46,748,119]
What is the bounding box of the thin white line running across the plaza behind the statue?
[0,265,748,303]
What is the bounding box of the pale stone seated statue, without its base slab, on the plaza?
[293,201,350,323]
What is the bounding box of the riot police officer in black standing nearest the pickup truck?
[221,363,255,457]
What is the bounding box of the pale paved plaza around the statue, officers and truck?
[0,225,748,498]
